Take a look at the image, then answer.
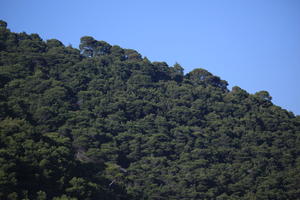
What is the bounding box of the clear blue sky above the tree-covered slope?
[0,0,300,115]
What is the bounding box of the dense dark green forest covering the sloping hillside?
[0,21,300,200]
